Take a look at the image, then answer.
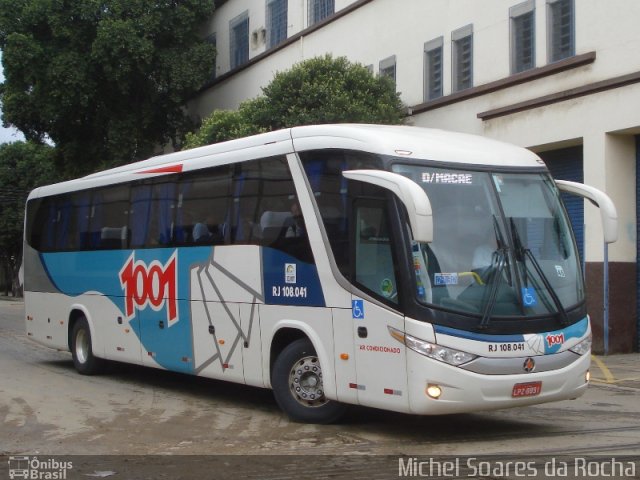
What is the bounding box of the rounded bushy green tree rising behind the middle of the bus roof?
[185,55,406,148]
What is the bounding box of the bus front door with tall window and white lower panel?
[351,199,408,411]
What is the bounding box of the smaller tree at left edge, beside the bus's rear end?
[0,142,58,294]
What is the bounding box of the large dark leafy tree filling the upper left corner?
[0,0,215,175]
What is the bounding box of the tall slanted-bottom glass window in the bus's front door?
[354,200,398,304]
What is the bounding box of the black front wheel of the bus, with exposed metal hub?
[271,338,346,424]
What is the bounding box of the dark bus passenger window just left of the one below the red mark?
[89,186,130,250]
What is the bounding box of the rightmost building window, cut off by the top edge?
[547,0,575,62]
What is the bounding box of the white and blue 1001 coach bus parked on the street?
[24,125,617,422]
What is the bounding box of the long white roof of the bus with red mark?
[29,124,544,198]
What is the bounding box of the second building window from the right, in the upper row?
[509,0,535,73]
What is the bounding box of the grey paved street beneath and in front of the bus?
[0,299,640,478]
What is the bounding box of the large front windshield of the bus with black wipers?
[393,164,584,316]
